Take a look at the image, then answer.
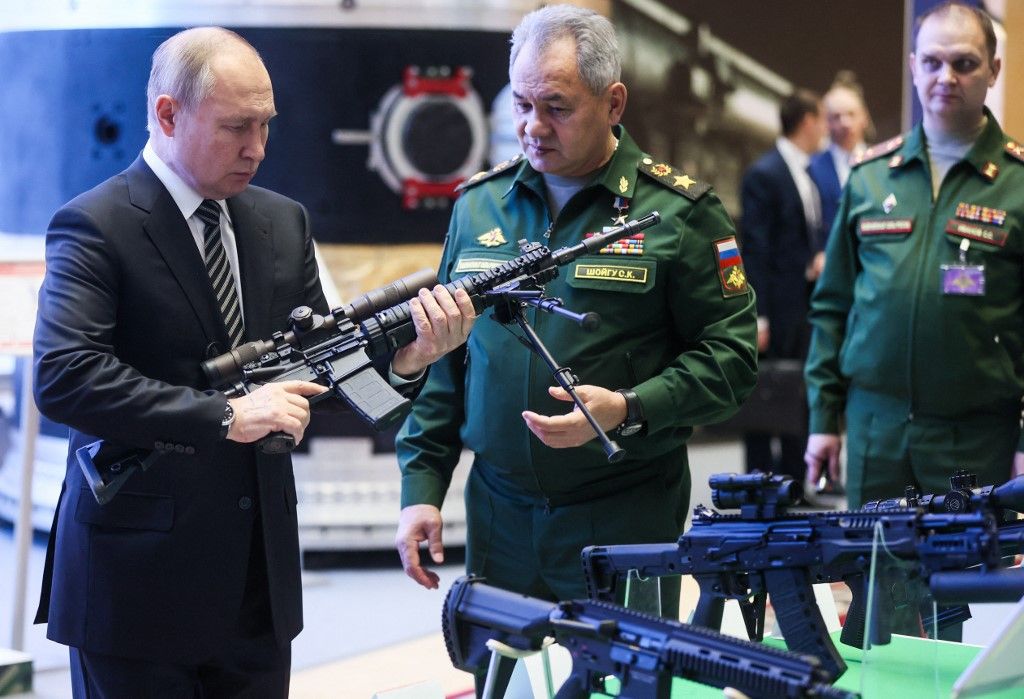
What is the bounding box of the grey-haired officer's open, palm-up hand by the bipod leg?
[522,385,626,449]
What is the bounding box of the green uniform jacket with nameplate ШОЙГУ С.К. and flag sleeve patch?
[397,129,757,507]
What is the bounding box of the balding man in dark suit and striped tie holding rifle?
[35,28,473,697]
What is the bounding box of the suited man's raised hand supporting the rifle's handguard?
[391,285,476,379]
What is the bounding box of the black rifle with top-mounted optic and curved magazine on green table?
[582,473,1022,674]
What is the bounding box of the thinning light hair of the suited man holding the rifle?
[145,27,262,133]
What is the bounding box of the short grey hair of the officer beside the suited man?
[509,5,623,94]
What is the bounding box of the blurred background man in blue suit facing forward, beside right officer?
[807,77,871,253]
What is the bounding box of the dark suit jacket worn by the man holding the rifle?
[35,158,327,662]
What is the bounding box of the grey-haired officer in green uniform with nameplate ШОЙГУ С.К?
[396,5,757,614]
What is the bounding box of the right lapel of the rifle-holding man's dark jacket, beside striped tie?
[227,190,273,341]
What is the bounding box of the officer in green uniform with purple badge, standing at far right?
[805,3,1024,506]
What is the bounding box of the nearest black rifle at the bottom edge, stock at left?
[441,576,858,699]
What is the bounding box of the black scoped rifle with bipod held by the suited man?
[76,211,662,505]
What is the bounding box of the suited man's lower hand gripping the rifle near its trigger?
[227,381,328,444]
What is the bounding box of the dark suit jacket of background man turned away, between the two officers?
[740,148,814,358]
